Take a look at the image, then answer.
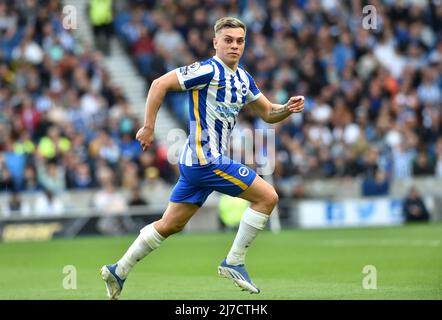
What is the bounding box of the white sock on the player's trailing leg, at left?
[116,223,165,279]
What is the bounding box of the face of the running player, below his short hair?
[213,28,245,67]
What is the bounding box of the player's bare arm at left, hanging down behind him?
[136,70,183,151]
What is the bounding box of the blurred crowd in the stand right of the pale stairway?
[114,0,442,196]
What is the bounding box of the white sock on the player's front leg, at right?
[227,207,269,265]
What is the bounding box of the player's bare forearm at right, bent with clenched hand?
[249,94,304,123]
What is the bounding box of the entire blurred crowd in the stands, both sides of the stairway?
[0,0,442,204]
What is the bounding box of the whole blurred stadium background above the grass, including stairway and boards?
[0,0,442,241]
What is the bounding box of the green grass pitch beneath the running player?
[0,223,442,300]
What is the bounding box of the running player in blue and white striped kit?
[100,17,304,299]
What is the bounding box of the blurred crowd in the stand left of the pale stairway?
[0,0,174,201]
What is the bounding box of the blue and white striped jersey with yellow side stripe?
[176,56,261,166]
